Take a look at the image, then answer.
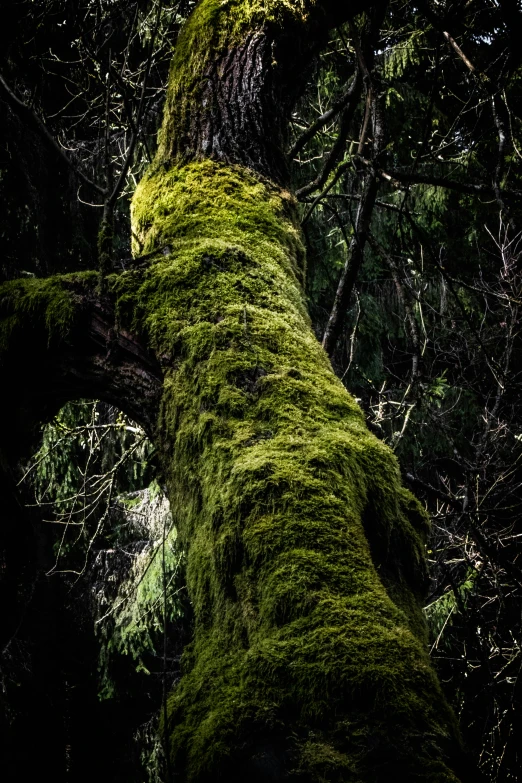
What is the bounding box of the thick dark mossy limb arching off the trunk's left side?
[0,272,161,440]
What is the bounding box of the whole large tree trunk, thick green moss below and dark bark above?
[4,0,464,783]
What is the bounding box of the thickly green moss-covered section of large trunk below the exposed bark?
[130,161,464,782]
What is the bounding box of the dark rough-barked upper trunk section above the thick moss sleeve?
[157,0,382,184]
